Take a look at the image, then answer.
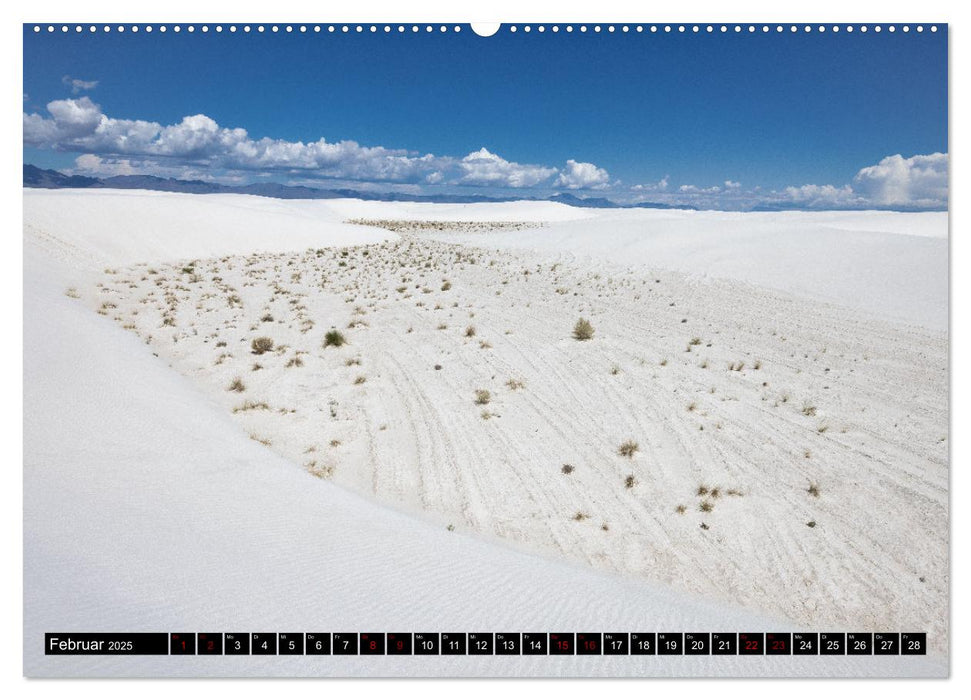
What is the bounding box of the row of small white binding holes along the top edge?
[34,24,937,34]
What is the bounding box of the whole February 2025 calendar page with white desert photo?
[22,16,951,678]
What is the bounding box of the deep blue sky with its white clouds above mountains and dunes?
[23,25,948,208]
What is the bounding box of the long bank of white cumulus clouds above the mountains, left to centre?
[23,96,592,189]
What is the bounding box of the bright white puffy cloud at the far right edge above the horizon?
[853,153,948,207]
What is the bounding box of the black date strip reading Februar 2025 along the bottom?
[44,632,927,656]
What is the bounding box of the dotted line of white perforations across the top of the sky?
[33,24,938,34]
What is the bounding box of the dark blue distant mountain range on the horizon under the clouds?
[24,164,693,209]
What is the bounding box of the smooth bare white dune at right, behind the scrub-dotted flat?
[428,210,948,331]
